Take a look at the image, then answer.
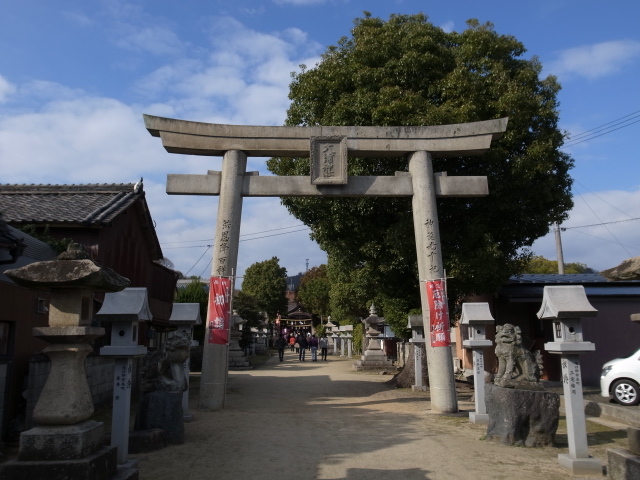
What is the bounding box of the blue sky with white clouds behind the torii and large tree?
[0,0,640,276]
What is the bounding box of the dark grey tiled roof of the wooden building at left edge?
[0,183,143,226]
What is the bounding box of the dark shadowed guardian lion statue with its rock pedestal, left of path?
[134,330,191,444]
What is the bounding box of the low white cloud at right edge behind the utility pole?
[532,189,640,271]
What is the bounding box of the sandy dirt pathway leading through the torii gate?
[134,352,604,480]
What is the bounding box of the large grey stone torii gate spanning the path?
[144,115,508,413]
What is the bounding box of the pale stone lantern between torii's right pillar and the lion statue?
[460,302,495,423]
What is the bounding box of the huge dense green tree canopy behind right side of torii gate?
[268,12,572,334]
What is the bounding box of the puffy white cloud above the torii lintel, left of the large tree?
[136,17,322,125]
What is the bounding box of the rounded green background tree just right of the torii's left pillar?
[242,257,287,320]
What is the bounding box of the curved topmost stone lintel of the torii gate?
[144,115,508,158]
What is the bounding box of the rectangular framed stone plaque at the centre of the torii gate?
[310,137,348,185]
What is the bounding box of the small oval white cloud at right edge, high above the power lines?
[548,40,640,79]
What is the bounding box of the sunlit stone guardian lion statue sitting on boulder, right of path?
[494,323,542,390]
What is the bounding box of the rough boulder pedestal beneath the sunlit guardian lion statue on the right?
[485,384,560,447]
